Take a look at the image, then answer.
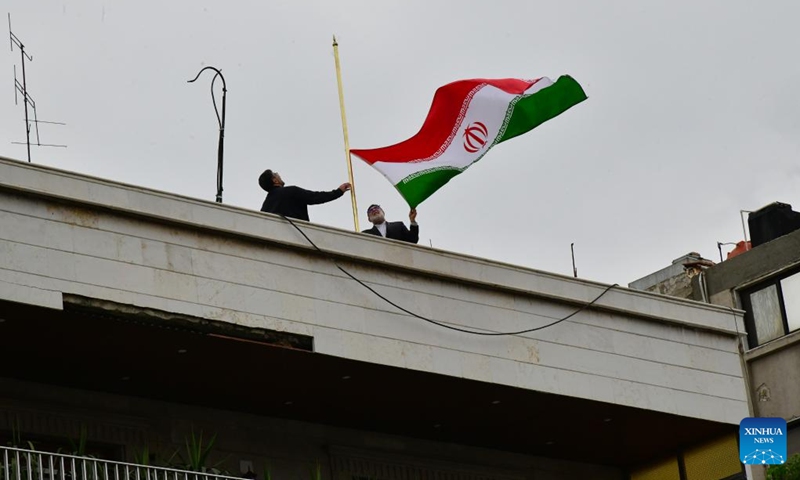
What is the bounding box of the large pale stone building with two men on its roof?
[0,159,752,480]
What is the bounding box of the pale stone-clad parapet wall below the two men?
[0,160,747,424]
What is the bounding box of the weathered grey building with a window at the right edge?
[630,203,800,480]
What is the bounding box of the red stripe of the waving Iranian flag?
[350,78,539,165]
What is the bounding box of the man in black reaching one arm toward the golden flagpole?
[258,170,350,221]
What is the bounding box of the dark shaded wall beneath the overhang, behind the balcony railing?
[0,378,625,480]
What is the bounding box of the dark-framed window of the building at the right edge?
[741,272,800,348]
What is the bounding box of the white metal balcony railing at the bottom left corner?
[0,447,247,480]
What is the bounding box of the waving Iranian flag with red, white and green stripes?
[351,75,586,208]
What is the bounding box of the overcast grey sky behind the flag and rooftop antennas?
[0,0,800,285]
